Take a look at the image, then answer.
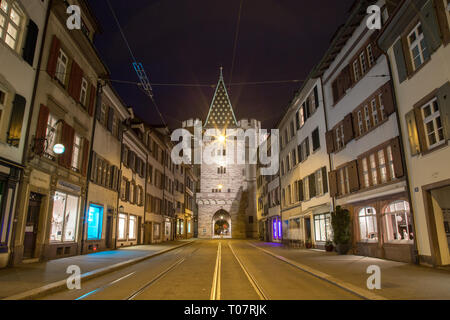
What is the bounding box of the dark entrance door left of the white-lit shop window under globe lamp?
[23,192,42,259]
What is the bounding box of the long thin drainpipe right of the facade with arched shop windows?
[383,52,420,264]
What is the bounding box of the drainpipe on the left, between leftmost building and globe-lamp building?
[10,0,53,264]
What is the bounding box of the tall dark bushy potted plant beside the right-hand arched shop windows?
[331,206,351,254]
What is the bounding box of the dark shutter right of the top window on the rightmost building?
[420,0,442,54]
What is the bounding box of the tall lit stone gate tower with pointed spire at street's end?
[183,68,261,239]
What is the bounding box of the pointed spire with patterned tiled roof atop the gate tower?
[204,67,237,128]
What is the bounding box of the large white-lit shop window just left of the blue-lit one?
[50,192,78,242]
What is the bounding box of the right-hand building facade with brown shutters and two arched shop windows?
[317,1,416,262]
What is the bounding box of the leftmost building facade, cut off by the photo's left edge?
[0,0,48,268]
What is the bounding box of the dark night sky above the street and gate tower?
[89,0,354,129]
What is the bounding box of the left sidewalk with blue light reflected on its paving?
[0,239,191,299]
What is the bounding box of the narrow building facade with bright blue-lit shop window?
[83,84,130,253]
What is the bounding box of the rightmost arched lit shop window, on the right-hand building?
[384,201,414,241]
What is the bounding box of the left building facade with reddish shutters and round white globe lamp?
[14,1,107,263]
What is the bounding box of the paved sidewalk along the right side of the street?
[252,242,450,300]
